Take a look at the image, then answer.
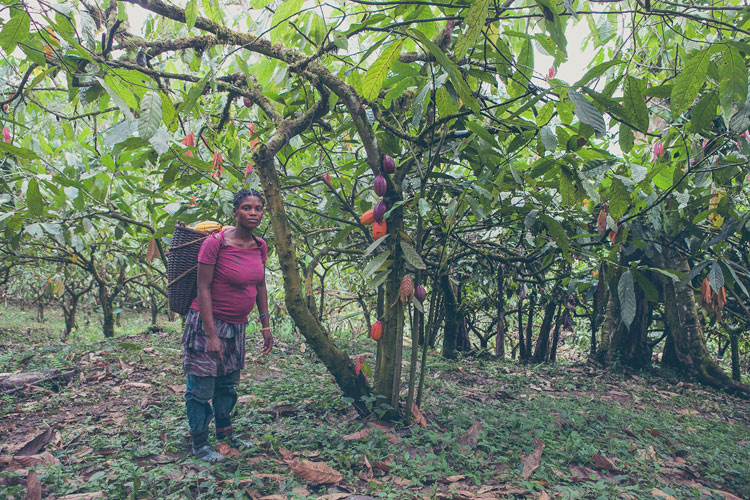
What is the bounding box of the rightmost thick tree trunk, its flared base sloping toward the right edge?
[660,255,750,398]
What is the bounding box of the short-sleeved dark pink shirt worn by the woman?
[190,232,268,325]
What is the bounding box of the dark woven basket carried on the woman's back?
[167,222,208,316]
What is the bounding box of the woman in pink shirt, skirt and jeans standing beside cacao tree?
[182,189,273,463]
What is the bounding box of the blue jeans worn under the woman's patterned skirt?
[185,370,240,449]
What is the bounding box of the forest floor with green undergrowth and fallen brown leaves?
[0,306,750,500]
